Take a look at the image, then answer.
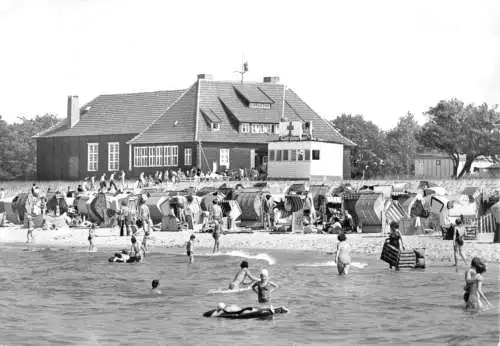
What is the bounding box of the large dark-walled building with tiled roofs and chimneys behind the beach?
[36,75,355,180]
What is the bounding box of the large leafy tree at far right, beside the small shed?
[418,99,500,178]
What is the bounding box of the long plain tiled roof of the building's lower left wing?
[36,90,184,138]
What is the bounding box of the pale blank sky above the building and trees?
[0,0,500,129]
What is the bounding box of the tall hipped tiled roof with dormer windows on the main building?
[129,80,356,146]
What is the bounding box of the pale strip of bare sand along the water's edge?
[0,225,500,263]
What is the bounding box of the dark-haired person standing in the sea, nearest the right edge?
[464,257,489,310]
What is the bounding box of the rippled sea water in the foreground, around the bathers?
[0,245,500,345]
